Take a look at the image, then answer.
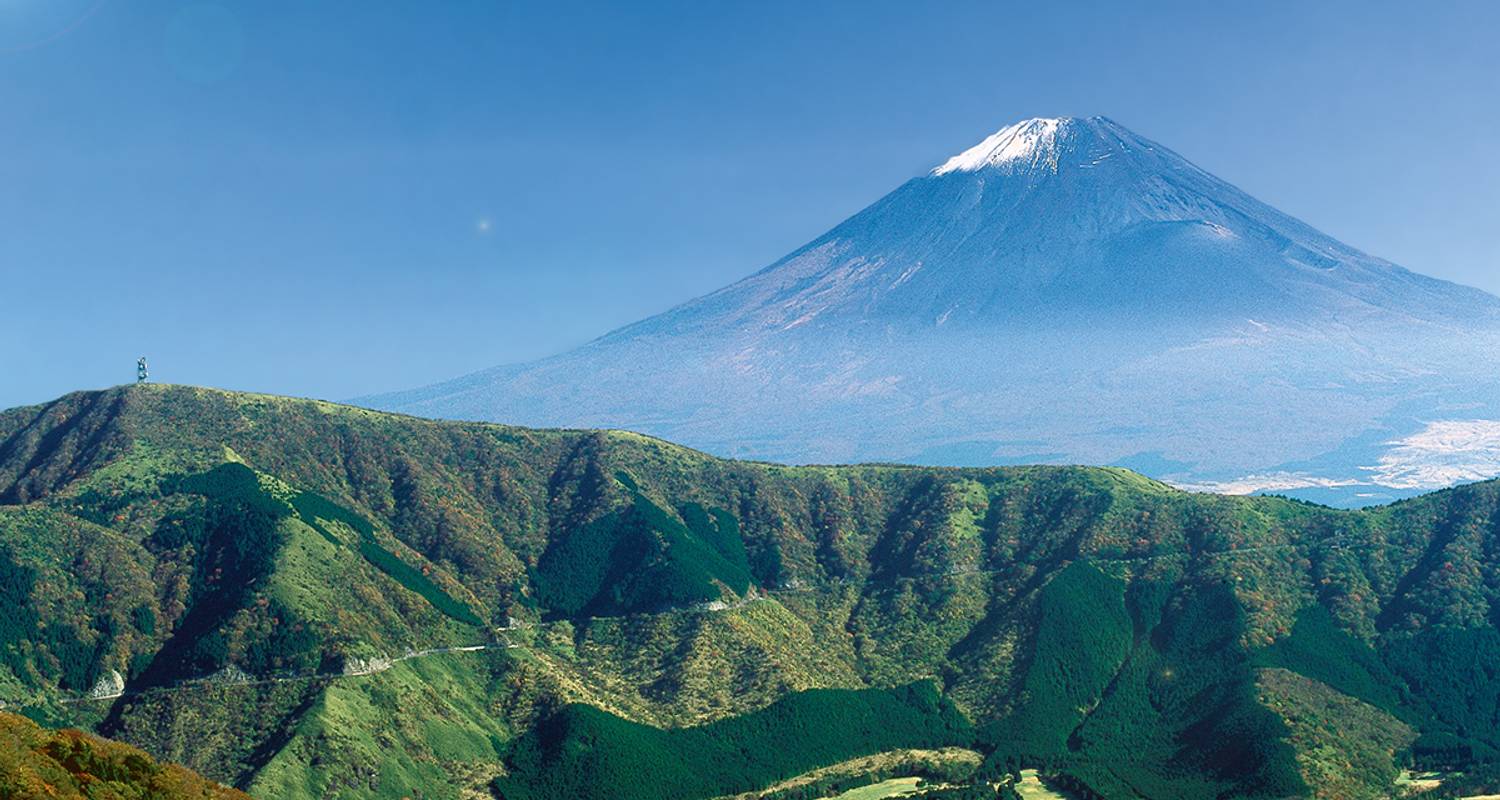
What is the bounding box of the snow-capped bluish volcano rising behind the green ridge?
[362,117,1500,504]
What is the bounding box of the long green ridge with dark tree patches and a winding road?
[0,384,1500,798]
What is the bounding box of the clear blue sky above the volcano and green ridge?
[0,0,1500,407]
